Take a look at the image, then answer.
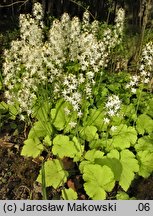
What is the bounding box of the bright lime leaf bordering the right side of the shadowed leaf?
[107,149,139,191]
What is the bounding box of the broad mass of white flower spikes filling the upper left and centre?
[3,3,124,117]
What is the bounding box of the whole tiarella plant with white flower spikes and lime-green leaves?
[3,4,153,199]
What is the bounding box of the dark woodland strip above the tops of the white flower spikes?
[0,0,153,31]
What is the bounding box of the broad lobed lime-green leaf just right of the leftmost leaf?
[52,134,83,160]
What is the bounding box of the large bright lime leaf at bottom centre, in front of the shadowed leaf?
[83,164,115,200]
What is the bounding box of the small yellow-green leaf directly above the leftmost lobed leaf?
[28,121,52,138]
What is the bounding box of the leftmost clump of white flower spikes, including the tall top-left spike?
[3,4,44,114]
